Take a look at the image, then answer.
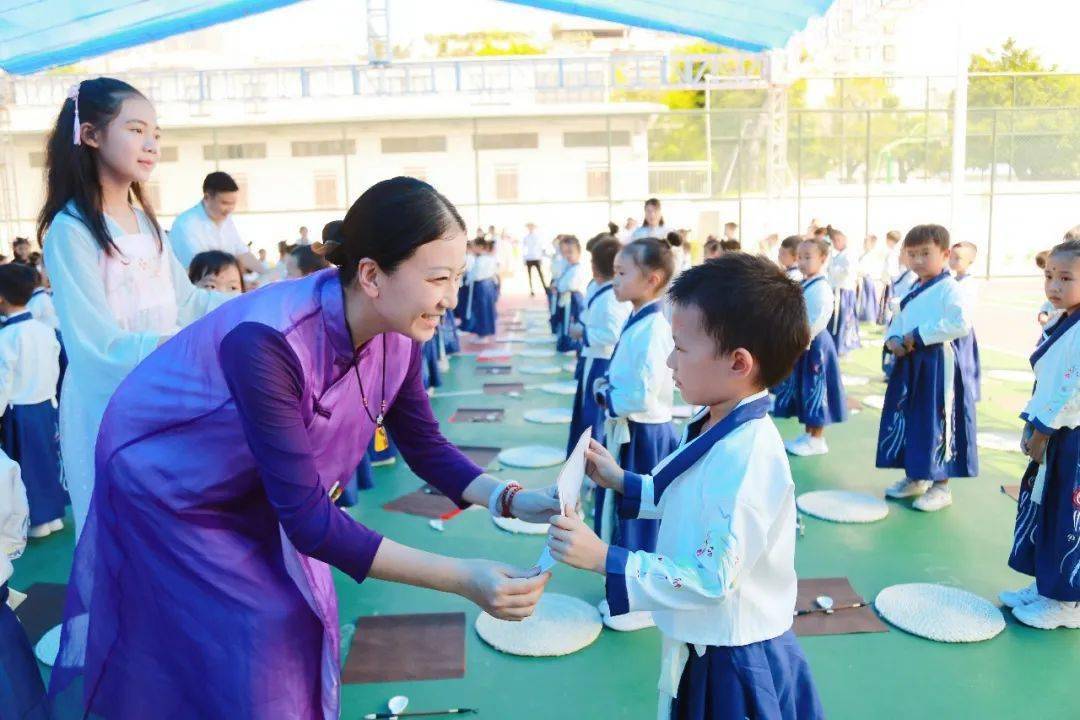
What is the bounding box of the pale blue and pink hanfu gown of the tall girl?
[44,203,228,535]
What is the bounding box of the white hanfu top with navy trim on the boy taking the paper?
[607,391,798,717]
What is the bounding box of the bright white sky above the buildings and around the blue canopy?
[95,0,1080,70]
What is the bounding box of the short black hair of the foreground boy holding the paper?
[669,253,810,388]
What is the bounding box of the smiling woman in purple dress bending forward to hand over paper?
[51,177,558,719]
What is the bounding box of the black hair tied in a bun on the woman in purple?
[326,176,465,284]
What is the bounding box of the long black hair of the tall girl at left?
[38,78,162,255]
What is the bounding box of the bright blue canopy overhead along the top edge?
[0,0,833,74]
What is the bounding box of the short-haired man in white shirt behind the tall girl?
[168,172,267,273]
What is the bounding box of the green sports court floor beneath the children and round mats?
[11,293,1080,720]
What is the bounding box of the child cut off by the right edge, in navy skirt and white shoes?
[999,240,1080,630]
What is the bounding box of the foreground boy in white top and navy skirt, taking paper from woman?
[548,253,824,720]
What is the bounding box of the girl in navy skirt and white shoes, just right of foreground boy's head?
[772,237,848,457]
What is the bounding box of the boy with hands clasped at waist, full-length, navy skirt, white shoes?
[877,225,978,512]
